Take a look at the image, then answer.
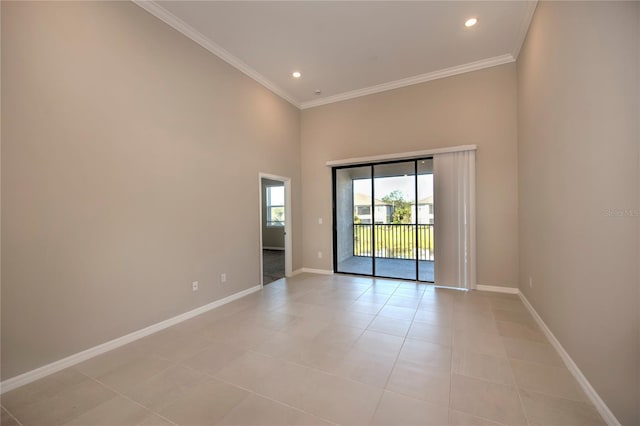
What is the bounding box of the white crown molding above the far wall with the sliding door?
[300,54,515,109]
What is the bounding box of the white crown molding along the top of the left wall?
[132,0,300,109]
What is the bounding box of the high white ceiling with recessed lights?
[137,1,536,108]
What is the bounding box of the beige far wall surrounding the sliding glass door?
[302,64,518,287]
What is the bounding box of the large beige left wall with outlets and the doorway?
[2,2,302,379]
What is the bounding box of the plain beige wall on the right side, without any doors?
[518,2,640,425]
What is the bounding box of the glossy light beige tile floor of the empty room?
[2,274,604,426]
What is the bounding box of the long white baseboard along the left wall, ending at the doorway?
[0,285,262,394]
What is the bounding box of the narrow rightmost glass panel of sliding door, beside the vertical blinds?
[417,159,435,282]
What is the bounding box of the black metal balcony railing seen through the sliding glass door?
[353,224,434,261]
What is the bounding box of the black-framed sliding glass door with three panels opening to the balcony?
[333,159,435,282]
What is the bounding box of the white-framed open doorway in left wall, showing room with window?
[259,173,291,285]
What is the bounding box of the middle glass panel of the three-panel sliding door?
[373,161,417,280]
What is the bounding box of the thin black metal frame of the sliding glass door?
[331,155,435,284]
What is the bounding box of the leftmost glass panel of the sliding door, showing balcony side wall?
[334,166,373,275]
